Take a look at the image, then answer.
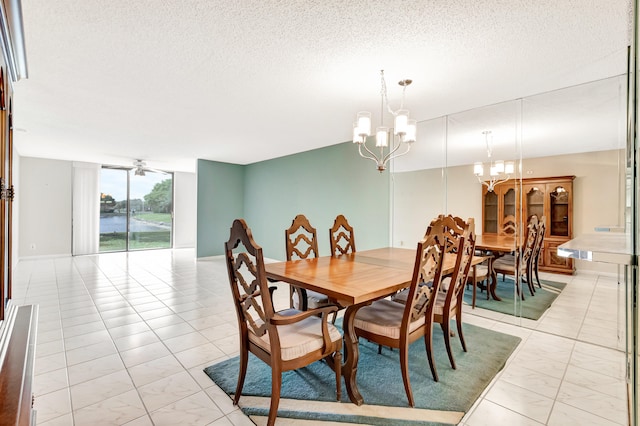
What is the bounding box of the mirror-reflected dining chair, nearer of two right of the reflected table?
[493,215,538,300]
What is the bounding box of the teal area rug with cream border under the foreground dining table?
[204,324,520,425]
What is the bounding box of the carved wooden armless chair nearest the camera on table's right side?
[354,230,444,407]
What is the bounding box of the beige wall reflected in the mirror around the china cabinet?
[392,150,624,272]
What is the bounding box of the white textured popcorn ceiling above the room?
[8,0,630,171]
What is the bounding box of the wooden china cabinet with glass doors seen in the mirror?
[482,176,575,274]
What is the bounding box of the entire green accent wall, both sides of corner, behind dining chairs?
[197,142,390,260]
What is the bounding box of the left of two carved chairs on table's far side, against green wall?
[284,214,335,312]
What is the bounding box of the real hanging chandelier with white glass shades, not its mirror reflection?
[353,70,417,173]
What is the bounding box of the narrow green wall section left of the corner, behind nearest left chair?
[196,160,245,257]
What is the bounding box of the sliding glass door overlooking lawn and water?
[100,167,173,252]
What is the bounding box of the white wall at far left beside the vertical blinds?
[15,157,71,258]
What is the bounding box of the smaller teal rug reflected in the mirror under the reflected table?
[464,277,567,320]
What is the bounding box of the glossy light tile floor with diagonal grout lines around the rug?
[12,249,627,426]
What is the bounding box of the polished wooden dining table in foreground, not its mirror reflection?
[265,247,484,405]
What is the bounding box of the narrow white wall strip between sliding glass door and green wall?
[173,172,198,248]
